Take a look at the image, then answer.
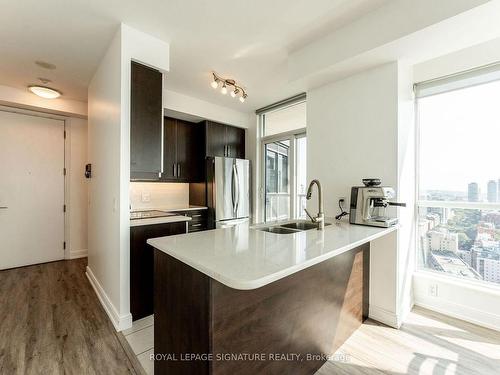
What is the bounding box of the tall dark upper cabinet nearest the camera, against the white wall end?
[130,62,163,180]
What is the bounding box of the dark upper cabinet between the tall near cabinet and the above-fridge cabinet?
[162,117,204,182]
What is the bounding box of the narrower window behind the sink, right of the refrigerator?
[259,95,307,221]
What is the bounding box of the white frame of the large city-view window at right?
[413,81,500,292]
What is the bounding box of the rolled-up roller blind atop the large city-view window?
[414,63,500,98]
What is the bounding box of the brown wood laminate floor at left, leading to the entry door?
[0,258,136,375]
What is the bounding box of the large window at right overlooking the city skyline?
[416,70,500,285]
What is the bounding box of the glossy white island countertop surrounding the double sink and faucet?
[147,220,396,290]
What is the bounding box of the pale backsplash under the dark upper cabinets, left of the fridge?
[130,182,189,211]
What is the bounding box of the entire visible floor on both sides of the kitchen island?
[0,259,500,375]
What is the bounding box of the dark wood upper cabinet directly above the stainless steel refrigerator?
[205,121,245,159]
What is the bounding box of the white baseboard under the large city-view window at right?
[415,295,500,331]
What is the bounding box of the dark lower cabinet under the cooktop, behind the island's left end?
[130,221,186,320]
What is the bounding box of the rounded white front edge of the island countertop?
[147,225,399,290]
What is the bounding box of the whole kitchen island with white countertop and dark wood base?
[148,223,396,374]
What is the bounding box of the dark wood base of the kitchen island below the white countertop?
[154,244,370,375]
